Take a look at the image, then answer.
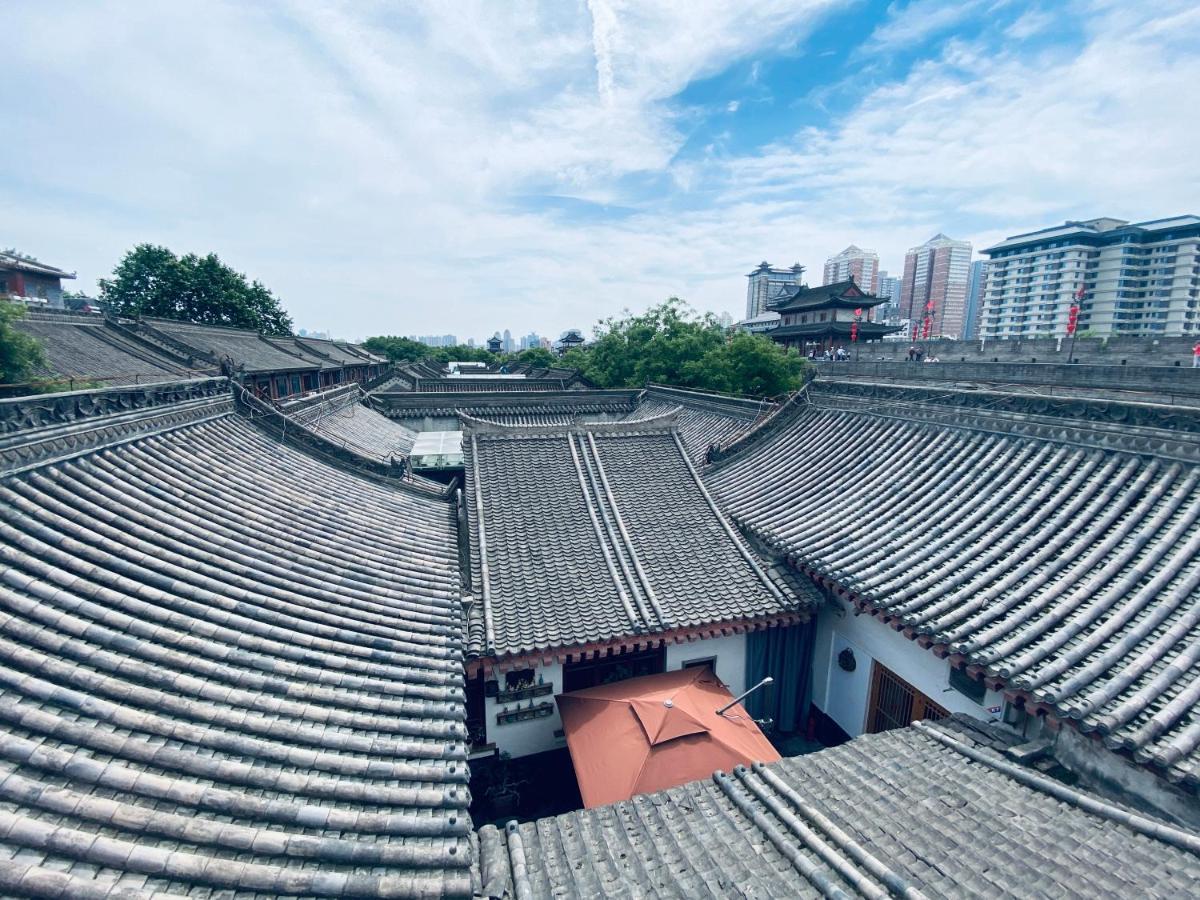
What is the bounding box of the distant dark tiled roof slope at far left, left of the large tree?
[17,313,198,384]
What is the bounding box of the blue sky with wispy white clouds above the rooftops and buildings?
[0,0,1200,340]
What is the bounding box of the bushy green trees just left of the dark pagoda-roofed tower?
[559,298,806,396]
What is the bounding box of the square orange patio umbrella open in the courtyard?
[557,668,780,809]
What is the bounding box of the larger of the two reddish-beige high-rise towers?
[900,234,971,338]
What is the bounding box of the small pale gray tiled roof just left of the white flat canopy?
[281,384,416,462]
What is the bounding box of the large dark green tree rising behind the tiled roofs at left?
[100,244,292,335]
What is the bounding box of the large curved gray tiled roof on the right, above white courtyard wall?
[707,383,1200,787]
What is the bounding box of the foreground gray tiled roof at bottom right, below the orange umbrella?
[480,719,1200,900]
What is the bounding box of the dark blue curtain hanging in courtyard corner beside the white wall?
[745,622,817,731]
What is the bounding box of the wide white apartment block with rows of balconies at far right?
[979,216,1200,338]
